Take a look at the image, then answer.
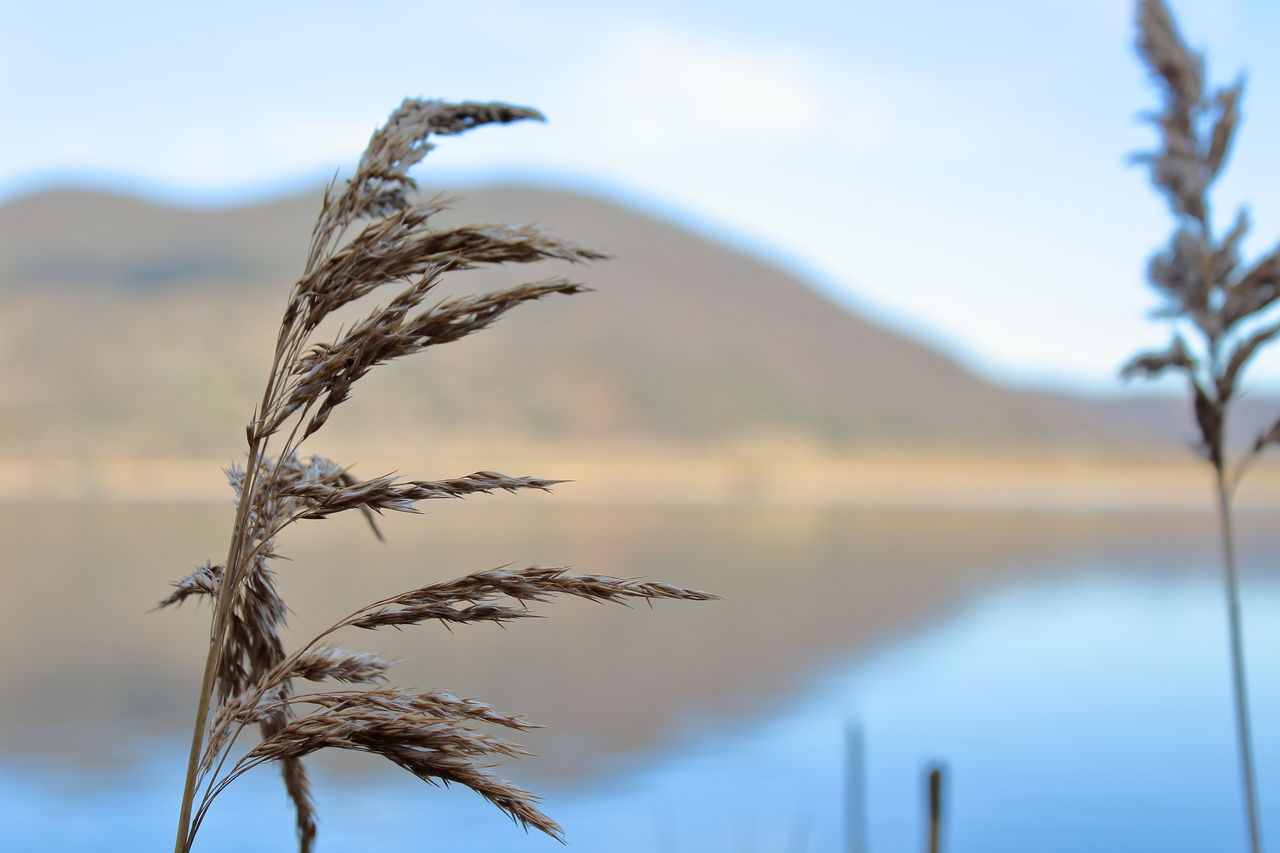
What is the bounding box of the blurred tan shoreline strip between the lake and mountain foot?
[0,452,1280,511]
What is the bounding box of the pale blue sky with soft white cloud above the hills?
[0,0,1280,391]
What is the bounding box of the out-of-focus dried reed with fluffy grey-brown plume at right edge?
[1123,0,1280,853]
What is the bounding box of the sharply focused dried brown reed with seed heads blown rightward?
[161,100,714,853]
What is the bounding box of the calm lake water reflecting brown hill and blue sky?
[0,496,1280,853]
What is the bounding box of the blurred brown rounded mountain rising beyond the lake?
[0,187,1249,455]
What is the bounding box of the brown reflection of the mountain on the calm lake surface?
[0,498,1261,779]
